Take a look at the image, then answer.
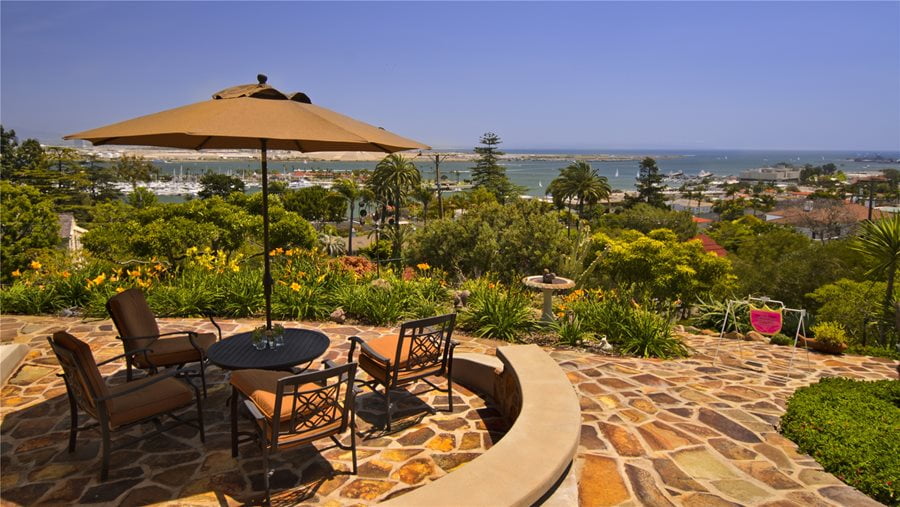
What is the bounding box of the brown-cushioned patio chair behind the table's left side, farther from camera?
[106,289,222,398]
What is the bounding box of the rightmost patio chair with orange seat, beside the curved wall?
[349,313,456,431]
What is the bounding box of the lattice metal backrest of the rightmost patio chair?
[392,313,456,378]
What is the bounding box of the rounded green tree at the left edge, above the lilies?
[0,181,60,282]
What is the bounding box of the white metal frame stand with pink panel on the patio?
[713,296,810,371]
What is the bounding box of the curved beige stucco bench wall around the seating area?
[385,345,581,507]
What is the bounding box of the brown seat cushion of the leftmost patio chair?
[107,376,194,428]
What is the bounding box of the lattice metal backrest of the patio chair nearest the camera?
[271,363,356,447]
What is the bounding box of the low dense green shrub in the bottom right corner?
[781,378,900,506]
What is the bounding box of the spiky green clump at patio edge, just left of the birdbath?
[461,280,535,341]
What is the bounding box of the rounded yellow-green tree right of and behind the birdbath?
[589,229,735,302]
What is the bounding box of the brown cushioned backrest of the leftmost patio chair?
[47,331,109,418]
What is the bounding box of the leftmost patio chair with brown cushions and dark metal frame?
[47,331,206,481]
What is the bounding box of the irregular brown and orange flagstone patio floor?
[0,316,897,506]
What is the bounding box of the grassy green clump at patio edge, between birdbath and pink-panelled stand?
[615,308,688,359]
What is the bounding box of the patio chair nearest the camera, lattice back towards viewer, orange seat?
[231,363,357,503]
